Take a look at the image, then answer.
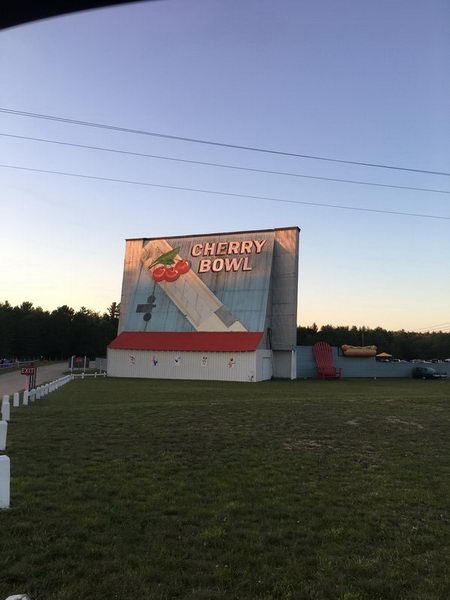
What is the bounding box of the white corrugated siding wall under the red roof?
[108,349,263,382]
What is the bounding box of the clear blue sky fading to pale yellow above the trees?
[0,0,450,330]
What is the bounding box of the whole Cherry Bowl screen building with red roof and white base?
[108,227,299,381]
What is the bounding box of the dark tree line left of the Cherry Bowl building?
[0,301,120,360]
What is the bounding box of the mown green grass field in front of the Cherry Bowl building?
[0,378,450,600]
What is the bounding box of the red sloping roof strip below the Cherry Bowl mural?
[108,331,263,352]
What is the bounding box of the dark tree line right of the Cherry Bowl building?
[297,323,450,360]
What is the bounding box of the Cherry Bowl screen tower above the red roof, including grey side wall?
[119,228,298,346]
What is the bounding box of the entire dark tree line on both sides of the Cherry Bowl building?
[0,301,450,360]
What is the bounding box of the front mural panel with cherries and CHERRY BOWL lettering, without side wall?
[122,231,274,331]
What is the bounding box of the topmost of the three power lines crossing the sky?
[0,107,450,177]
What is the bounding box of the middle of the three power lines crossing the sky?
[0,133,450,194]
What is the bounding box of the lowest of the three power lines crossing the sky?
[0,164,450,221]
